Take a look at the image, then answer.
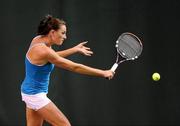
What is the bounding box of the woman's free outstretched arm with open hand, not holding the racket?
[56,42,93,57]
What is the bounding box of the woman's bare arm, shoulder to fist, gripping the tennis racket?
[42,46,114,79]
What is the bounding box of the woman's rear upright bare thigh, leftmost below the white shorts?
[26,108,43,126]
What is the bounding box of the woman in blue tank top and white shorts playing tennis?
[21,15,114,126]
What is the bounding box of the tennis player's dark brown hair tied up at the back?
[37,14,66,35]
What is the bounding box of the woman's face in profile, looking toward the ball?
[53,25,67,45]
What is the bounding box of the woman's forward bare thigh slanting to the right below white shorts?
[38,102,70,126]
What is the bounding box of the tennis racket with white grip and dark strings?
[111,32,143,72]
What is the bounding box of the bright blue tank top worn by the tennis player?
[21,57,54,95]
